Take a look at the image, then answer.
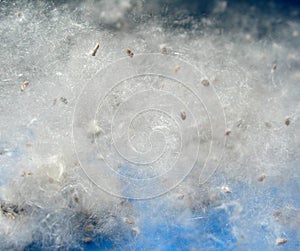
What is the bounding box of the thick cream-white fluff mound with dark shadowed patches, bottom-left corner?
[0,156,130,250]
